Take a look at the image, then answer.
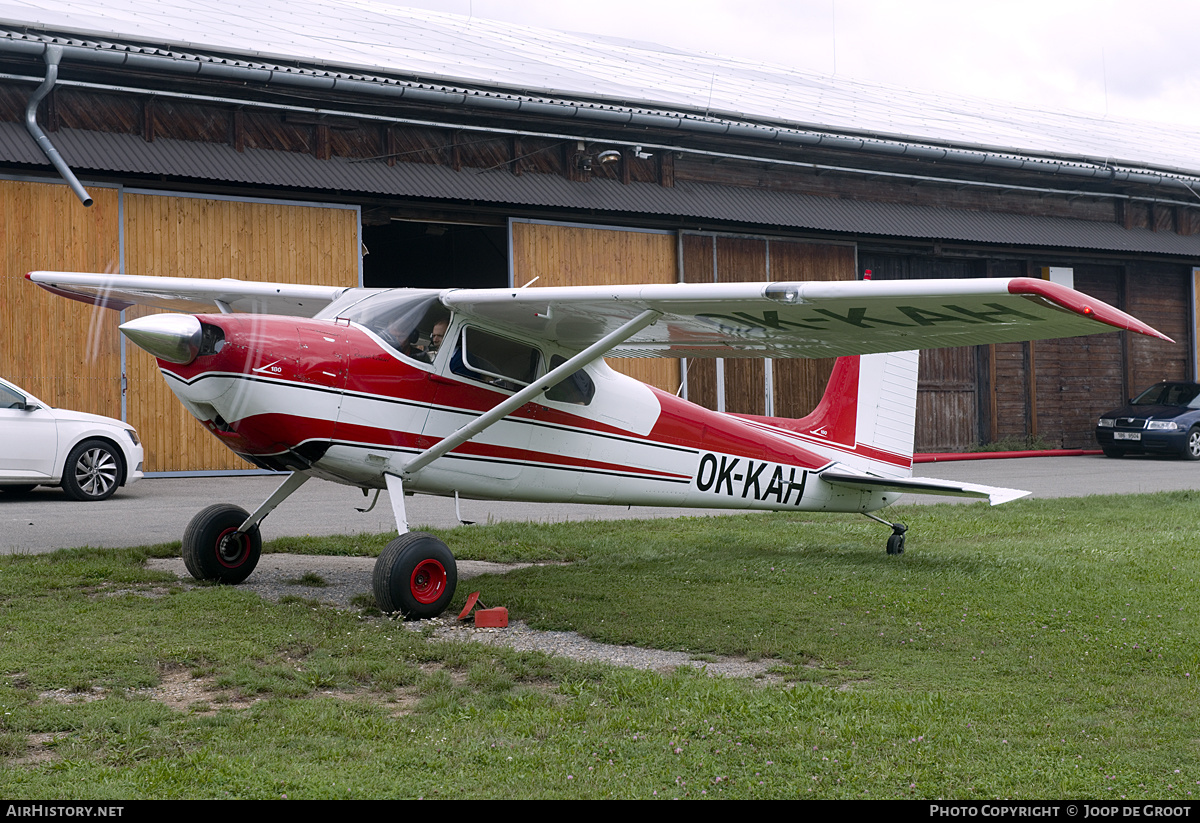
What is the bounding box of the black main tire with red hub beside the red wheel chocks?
[372,531,458,619]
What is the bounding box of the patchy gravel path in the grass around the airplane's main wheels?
[146,554,770,678]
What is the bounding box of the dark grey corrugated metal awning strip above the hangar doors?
[9,122,1200,258]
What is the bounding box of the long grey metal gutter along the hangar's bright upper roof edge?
[0,32,1200,197]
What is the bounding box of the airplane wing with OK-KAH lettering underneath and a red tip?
[442,277,1170,358]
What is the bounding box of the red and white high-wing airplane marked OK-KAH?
[26,271,1169,617]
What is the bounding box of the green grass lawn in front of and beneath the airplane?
[0,492,1200,800]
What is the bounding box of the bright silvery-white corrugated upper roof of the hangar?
[0,0,1200,174]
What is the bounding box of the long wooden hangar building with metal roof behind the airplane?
[0,0,1200,471]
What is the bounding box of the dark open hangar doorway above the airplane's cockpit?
[362,218,509,289]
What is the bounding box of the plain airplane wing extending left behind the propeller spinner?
[25,271,346,317]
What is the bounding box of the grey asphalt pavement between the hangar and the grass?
[0,456,1200,554]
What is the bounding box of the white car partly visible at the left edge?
[0,379,142,500]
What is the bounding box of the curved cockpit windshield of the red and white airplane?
[317,289,450,364]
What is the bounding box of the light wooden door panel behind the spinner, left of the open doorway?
[125,194,359,471]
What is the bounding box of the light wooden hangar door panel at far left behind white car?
[0,180,121,417]
